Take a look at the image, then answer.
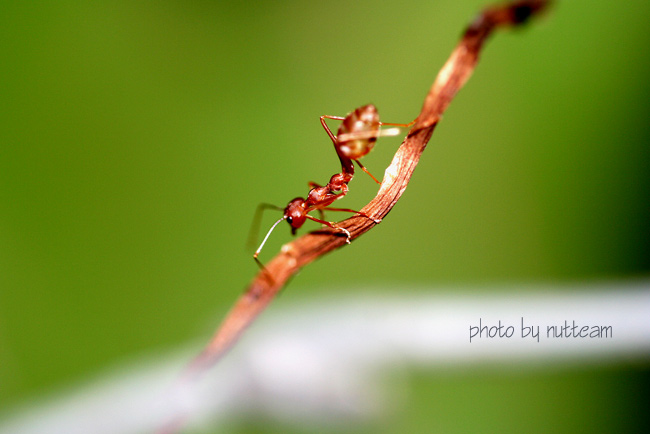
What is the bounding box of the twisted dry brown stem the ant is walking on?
[187,0,549,376]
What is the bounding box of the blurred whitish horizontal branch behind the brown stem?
[0,281,650,434]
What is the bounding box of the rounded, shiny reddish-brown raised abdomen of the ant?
[337,104,381,160]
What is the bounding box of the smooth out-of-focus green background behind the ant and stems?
[0,0,650,432]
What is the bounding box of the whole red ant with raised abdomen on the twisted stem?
[253,104,415,265]
